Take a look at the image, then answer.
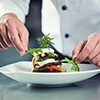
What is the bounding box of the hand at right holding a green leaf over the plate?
[72,33,100,67]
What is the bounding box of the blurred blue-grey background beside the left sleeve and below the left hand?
[0,0,42,67]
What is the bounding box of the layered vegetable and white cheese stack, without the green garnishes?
[27,48,65,72]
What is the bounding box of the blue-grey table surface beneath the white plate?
[0,73,100,100]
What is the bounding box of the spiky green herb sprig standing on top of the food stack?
[37,33,55,49]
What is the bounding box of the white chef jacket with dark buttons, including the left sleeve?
[0,0,100,56]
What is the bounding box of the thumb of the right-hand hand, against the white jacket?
[72,40,87,60]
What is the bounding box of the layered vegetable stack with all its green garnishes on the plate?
[26,34,79,72]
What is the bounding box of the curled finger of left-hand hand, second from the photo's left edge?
[0,23,12,47]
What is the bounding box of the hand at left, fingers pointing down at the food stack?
[0,13,29,55]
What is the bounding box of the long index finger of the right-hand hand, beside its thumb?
[75,33,100,64]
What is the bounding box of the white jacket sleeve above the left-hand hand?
[0,0,30,23]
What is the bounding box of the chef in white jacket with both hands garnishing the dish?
[0,0,100,67]
